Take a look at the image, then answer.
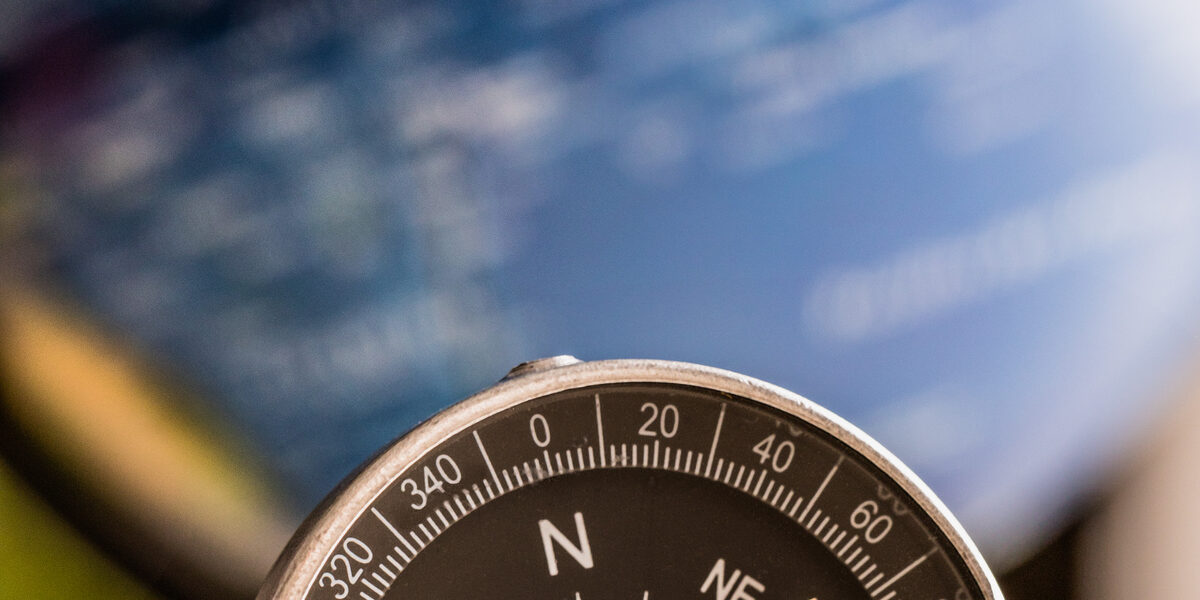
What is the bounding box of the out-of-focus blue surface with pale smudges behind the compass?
[0,0,1200,595]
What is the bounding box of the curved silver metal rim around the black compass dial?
[258,359,1003,600]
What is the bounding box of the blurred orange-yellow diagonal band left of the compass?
[0,290,293,589]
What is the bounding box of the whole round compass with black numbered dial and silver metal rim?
[260,361,1000,600]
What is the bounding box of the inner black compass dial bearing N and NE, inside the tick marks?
[386,468,870,600]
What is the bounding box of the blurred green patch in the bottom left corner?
[0,461,157,600]
